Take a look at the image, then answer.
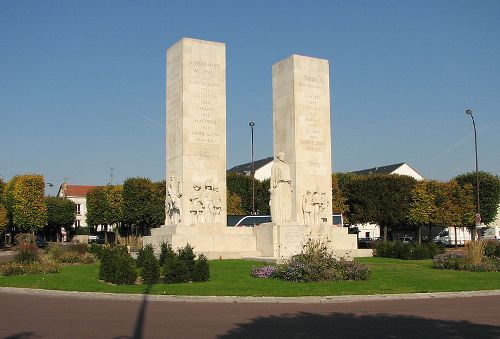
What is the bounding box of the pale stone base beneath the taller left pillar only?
[143,225,262,259]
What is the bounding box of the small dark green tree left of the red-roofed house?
[45,197,76,241]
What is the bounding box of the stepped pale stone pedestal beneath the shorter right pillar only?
[253,223,372,261]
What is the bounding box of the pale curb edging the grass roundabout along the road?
[0,287,500,304]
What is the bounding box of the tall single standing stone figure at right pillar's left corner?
[269,152,292,222]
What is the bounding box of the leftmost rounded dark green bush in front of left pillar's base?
[99,246,137,285]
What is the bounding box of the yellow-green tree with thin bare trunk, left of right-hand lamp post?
[408,181,436,244]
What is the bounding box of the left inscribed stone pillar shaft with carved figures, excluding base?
[165,38,226,226]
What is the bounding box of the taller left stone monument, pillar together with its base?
[144,38,259,259]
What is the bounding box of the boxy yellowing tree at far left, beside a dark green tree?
[12,174,47,233]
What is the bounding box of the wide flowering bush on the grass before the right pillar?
[268,241,370,282]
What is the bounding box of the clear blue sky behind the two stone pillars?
[0,0,500,194]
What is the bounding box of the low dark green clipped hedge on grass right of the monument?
[375,241,444,260]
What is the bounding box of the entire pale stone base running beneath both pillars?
[143,223,372,262]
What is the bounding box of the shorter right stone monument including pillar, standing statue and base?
[254,55,371,260]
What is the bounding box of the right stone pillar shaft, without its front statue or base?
[273,55,332,225]
